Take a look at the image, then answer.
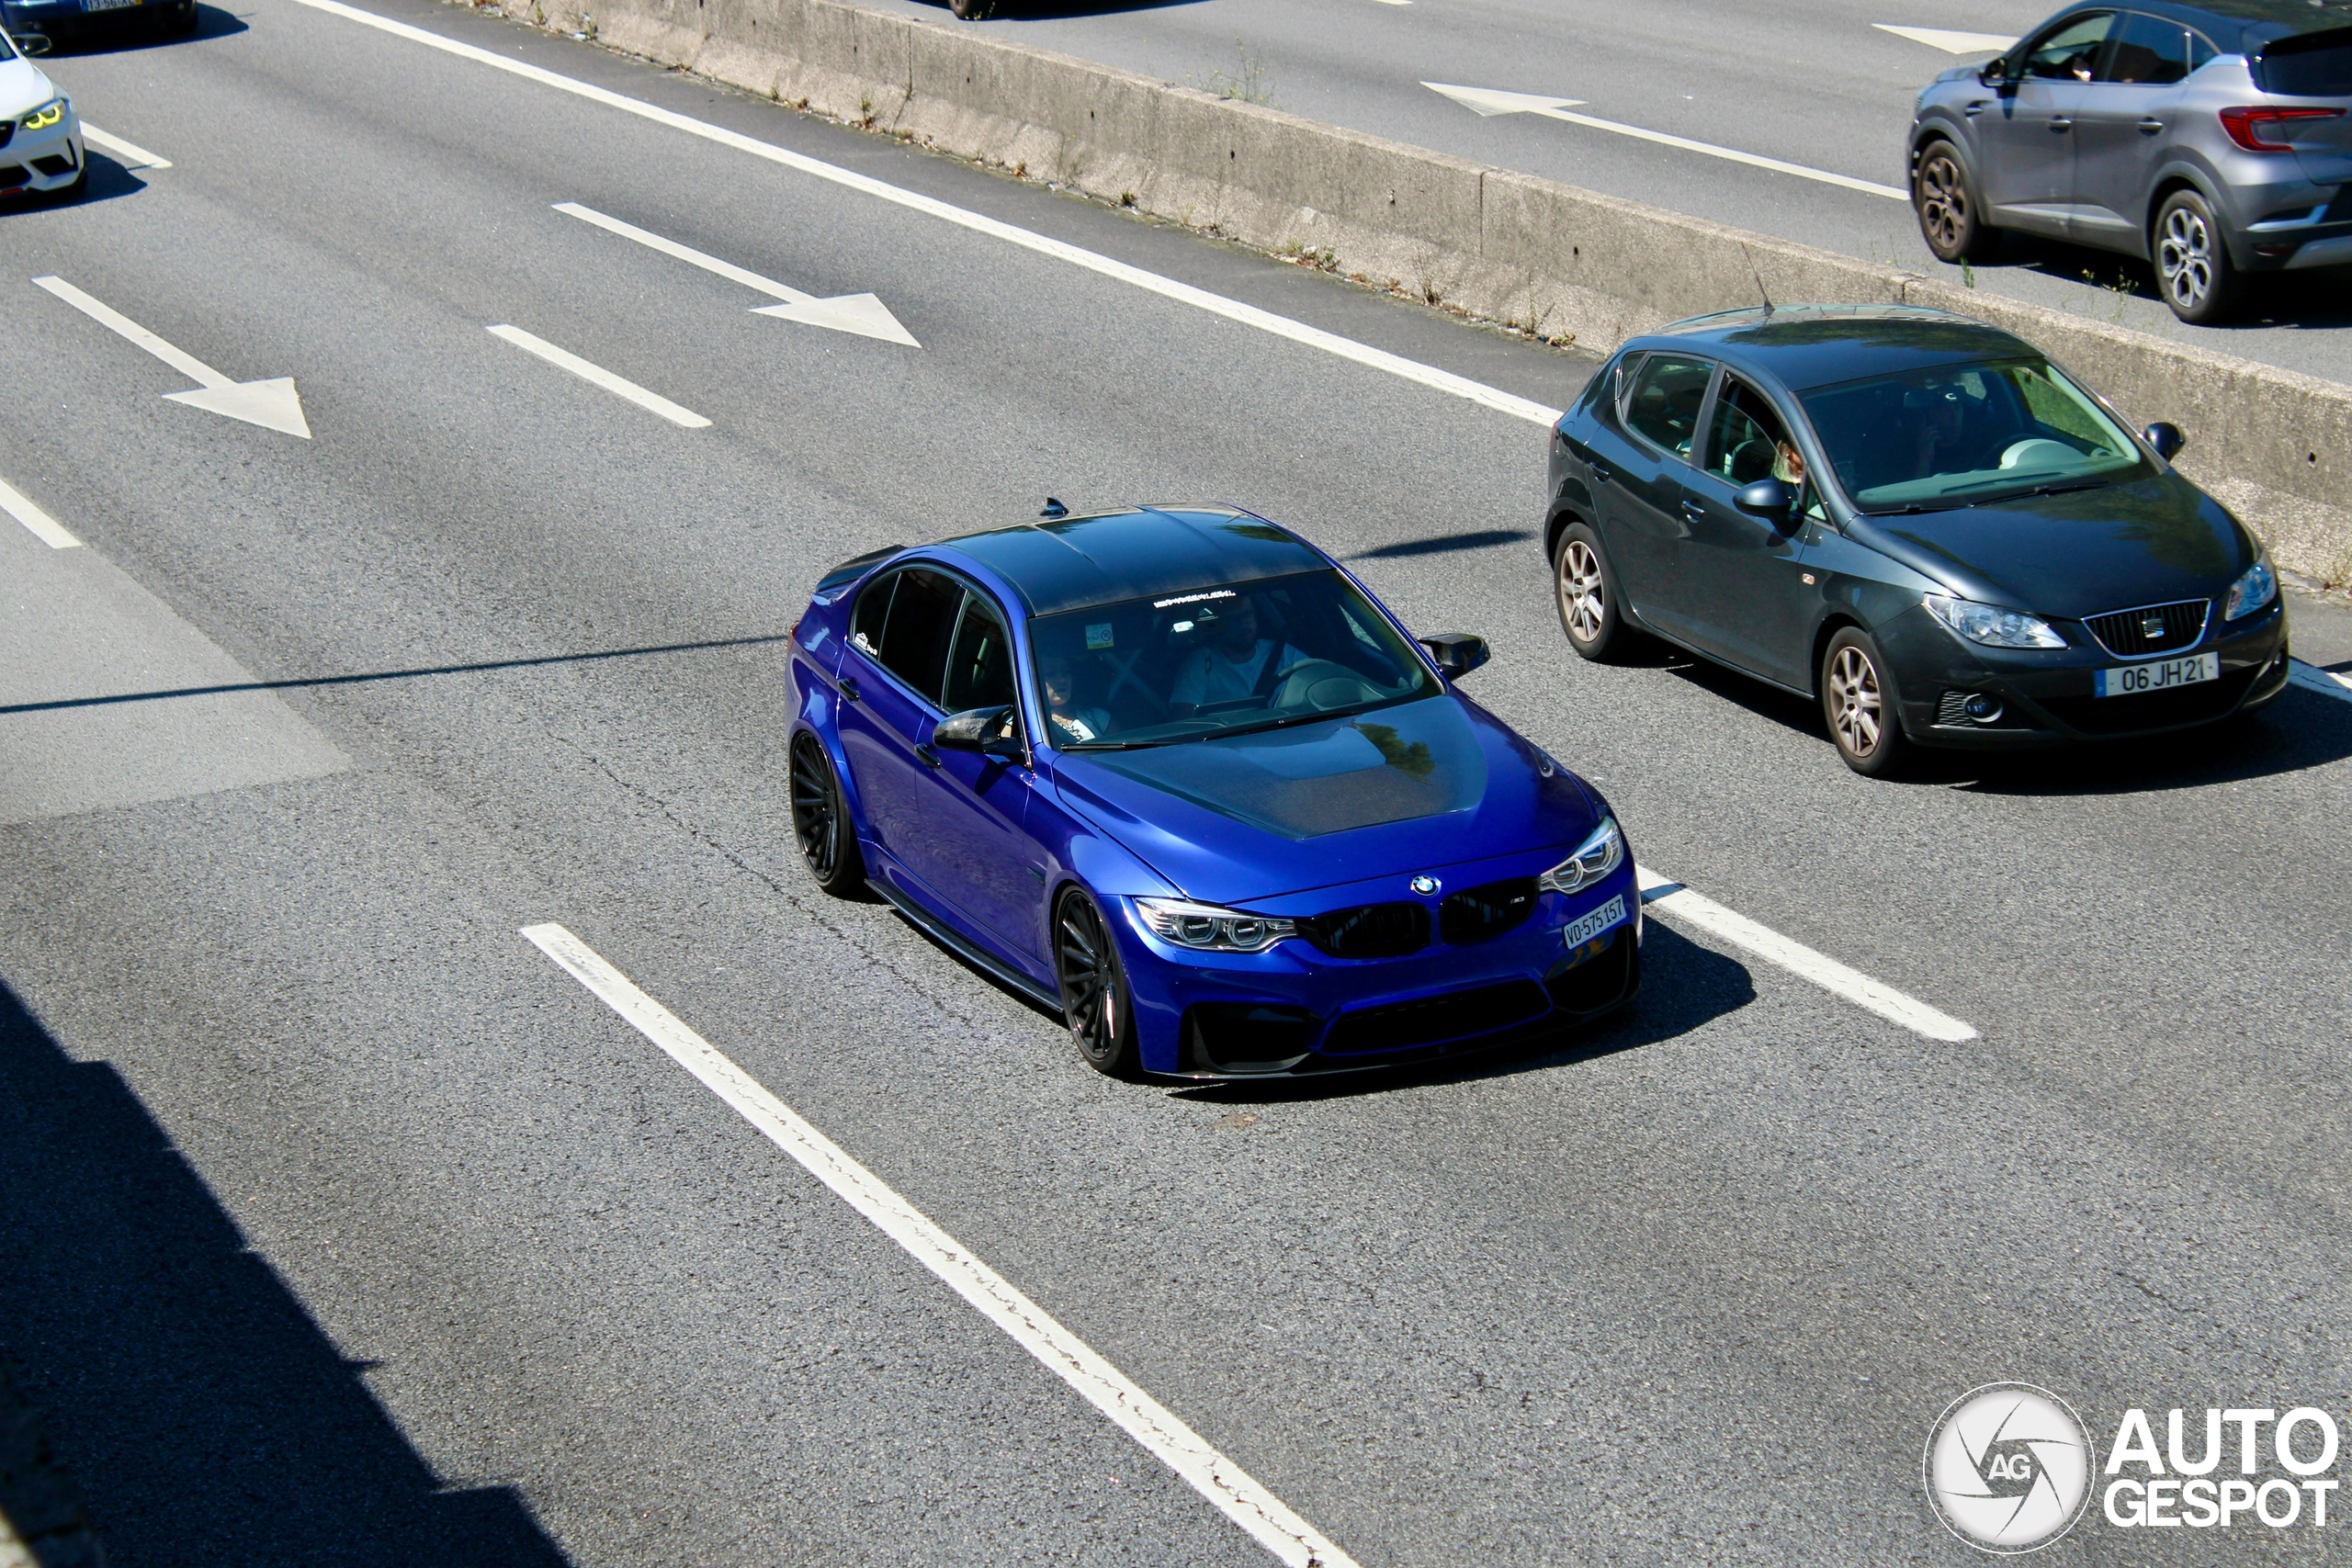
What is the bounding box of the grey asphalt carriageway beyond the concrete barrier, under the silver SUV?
[854,0,2352,381]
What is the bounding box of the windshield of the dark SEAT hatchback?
[1799,360,2147,513]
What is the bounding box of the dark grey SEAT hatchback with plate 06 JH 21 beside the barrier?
[1543,306,2289,776]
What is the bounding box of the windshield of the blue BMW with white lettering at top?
[1030,571,1437,750]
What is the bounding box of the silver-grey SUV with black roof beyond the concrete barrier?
[1910,0,2352,322]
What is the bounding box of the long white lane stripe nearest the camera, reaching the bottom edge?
[522,924,1355,1568]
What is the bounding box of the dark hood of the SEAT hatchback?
[1849,472,2258,621]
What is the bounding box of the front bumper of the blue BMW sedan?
[1113,849,1642,1081]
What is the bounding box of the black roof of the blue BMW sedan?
[941,505,1329,616]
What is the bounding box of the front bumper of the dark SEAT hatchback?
[1879,600,2289,750]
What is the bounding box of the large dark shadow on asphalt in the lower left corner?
[0,980,570,1568]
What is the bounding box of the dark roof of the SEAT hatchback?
[1637,306,2037,390]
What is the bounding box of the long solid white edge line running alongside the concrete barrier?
[279,0,1559,425]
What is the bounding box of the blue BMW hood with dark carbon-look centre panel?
[1056,694,1600,903]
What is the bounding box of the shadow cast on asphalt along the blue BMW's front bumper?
[1169,919,1757,1105]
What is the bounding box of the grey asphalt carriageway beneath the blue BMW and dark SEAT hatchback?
[0,0,2352,1568]
